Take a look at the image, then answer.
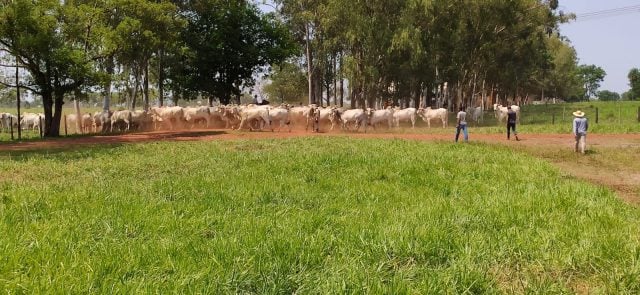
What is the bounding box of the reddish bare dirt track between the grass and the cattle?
[0,129,640,206]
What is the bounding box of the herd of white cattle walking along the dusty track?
[0,104,520,133]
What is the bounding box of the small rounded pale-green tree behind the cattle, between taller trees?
[264,62,308,105]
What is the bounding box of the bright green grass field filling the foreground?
[0,138,640,294]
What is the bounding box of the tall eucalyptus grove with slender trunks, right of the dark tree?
[267,0,640,108]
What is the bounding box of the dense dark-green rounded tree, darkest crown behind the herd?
[178,0,297,104]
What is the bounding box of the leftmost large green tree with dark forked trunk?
[0,0,103,137]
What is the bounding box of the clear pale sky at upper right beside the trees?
[559,0,640,94]
